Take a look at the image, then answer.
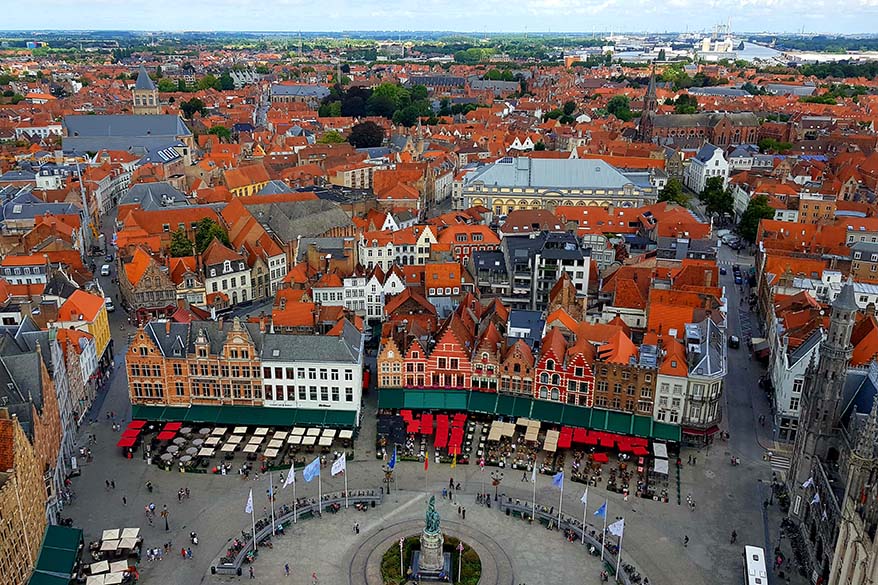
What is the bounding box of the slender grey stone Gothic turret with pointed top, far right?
[789,280,858,516]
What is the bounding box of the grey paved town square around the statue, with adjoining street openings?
[63,238,804,585]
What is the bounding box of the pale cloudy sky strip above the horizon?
[6,0,878,33]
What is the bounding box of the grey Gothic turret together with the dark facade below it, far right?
[788,281,859,583]
